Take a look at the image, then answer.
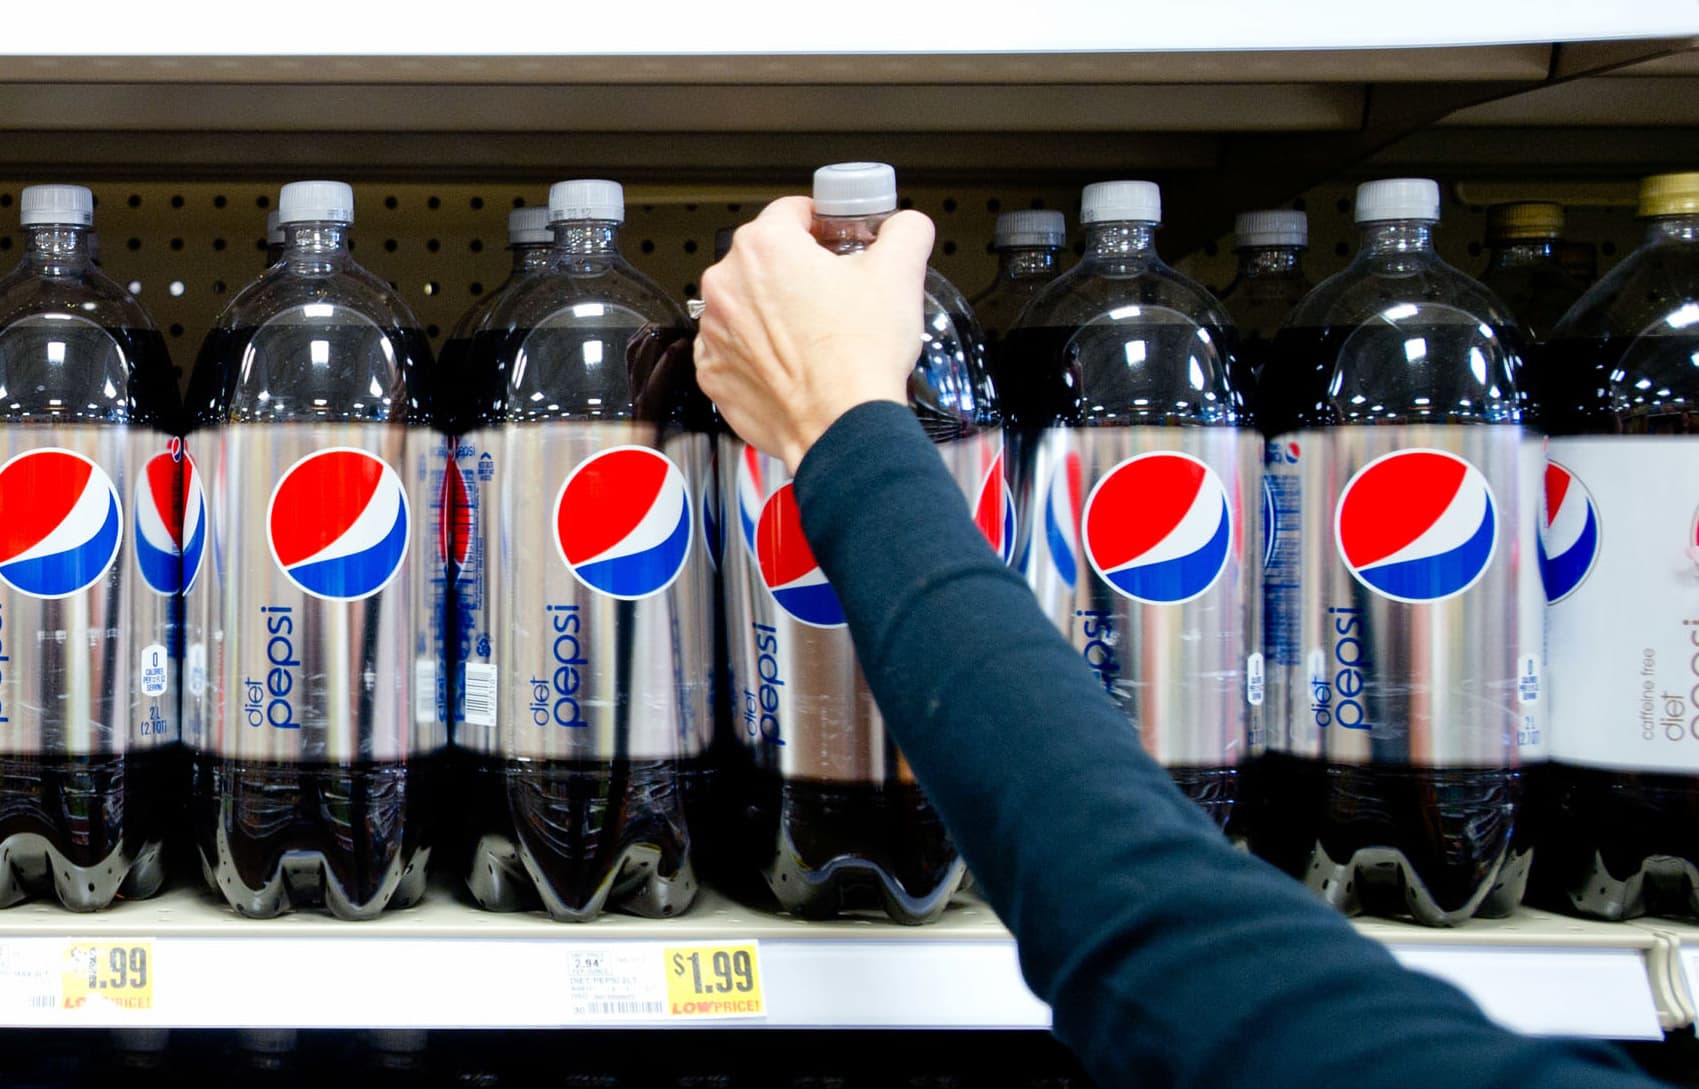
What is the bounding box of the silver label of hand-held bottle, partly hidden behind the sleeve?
[717,432,1016,783]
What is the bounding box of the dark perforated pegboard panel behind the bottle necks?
[0,180,1640,380]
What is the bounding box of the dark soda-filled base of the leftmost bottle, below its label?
[0,746,183,911]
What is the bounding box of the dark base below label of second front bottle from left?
[190,753,445,919]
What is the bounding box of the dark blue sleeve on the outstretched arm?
[797,403,1651,1089]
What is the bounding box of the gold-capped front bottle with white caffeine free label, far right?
[1534,173,1699,919]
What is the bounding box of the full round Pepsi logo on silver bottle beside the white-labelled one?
[1334,450,1499,605]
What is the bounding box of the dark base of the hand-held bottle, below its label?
[742,770,967,924]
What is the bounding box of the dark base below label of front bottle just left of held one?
[455,753,700,923]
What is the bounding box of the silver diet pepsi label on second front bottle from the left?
[203,423,445,763]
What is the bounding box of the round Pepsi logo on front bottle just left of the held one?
[554,447,691,601]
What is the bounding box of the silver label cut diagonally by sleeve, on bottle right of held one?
[1014,426,1266,768]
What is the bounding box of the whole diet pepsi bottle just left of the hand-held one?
[455,180,714,921]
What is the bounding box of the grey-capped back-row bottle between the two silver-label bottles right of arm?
[1222,209,1312,375]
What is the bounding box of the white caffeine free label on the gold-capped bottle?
[1539,437,1699,773]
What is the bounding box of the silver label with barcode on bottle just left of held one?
[452,423,714,761]
